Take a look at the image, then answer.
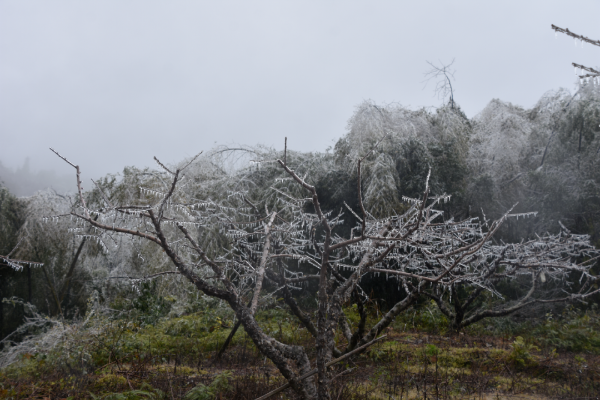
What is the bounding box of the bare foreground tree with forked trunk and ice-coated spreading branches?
[44,141,597,399]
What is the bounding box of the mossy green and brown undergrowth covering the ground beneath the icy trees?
[0,303,600,400]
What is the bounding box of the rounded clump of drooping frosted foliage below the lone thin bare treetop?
[335,101,471,215]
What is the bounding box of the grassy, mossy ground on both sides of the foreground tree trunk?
[0,309,600,400]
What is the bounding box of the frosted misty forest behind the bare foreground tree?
[0,82,600,400]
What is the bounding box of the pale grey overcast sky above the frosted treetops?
[0,0,600,182]
